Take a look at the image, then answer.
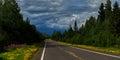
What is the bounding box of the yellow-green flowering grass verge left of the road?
[0,42,44,60]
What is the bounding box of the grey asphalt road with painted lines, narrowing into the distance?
[33,39,120,60]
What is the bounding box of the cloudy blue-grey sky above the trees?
[17,0,120,34]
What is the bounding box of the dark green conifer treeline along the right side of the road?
[51,0,120,48]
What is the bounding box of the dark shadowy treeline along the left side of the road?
[0,0,44,51]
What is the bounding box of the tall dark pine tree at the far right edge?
[111,2,120,35]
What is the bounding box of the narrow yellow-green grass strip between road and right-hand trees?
[59,42,120,56]
